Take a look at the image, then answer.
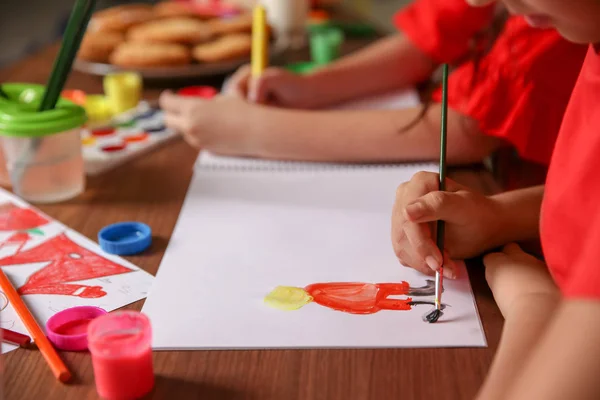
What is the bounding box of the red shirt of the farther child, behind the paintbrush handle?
[394,0,586,165]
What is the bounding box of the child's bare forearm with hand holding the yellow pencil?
[225,33,435,108]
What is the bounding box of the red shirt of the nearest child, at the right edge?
[541,47,600,300]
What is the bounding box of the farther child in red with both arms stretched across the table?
[161,0,585,165]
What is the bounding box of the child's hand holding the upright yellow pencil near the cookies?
[225,65,314,108]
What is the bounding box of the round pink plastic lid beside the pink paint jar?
[46,306,107,351]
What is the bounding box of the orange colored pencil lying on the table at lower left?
[0,269,71,382]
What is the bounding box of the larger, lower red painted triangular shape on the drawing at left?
[0,233,133,298]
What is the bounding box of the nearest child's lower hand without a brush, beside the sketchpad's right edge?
[483,243,559,318]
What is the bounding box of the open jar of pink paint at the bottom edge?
[88,311,154,400]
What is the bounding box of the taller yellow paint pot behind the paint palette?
[103,72,142,115]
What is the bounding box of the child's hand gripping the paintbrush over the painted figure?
[392,172,502,278]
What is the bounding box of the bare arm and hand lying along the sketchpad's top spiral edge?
[160,93,503,164]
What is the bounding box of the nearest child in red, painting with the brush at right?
[392,0,600,400]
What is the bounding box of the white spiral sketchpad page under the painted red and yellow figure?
[143,164,486,350]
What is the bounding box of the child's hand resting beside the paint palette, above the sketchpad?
[159,91,255,154]
